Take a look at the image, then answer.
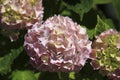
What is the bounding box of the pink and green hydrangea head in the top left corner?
[0,0,43,29]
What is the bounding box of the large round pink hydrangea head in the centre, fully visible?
[24,15,91,72]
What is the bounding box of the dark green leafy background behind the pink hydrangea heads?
[0,0,120,80]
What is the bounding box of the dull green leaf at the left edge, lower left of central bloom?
[0,47,23,74]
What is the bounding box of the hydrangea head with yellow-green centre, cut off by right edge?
[91,29,120,80]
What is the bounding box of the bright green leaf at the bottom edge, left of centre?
[11,70,37,80]
